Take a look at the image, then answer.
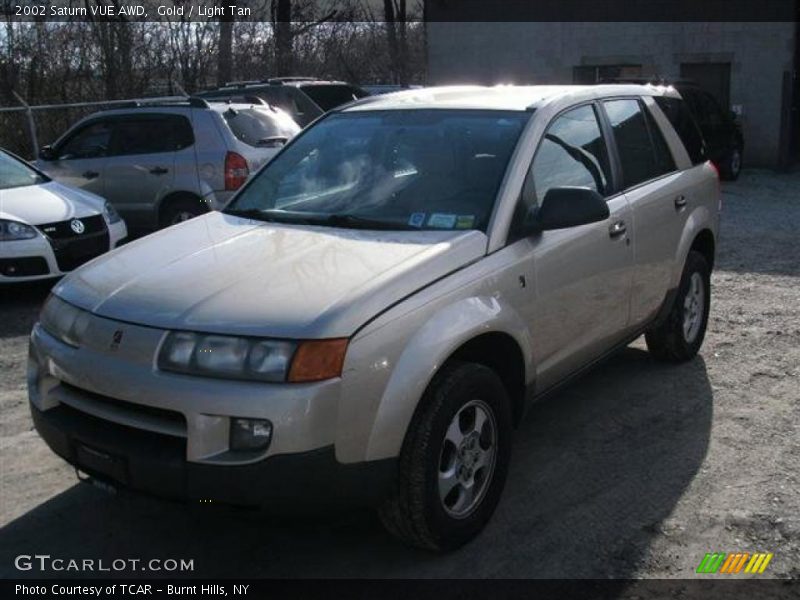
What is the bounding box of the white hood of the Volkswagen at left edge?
[0,181,105,225]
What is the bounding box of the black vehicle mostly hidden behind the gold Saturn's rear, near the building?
[613,77,744,180]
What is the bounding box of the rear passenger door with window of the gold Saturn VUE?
[602,98,691,327]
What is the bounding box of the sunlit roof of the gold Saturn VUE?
[344,84,675,111]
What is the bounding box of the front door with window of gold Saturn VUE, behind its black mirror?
[512,104,633,391]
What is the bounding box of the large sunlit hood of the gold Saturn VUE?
[54,213,487,339]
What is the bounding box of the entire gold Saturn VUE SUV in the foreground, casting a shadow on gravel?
[28,85,720,550]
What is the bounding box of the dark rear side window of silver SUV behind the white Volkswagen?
[111,115,194,156]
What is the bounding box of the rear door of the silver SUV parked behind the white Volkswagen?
[105,113,176,226]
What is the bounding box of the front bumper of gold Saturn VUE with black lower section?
[28,315,394,506]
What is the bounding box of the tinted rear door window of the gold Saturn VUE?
[603,99,674,188]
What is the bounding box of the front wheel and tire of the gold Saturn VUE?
[379,361,512,551]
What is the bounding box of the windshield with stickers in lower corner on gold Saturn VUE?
[226,109,530,231]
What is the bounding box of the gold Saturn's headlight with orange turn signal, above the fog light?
[158,331,347,382]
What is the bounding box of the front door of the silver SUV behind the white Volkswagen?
[37,119,111,196]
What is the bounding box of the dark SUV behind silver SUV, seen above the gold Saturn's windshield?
[197,77,369,127]
